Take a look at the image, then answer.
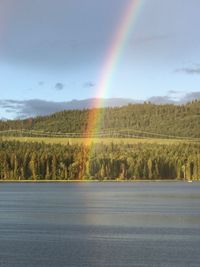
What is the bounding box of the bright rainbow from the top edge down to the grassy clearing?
[85,0,145,143]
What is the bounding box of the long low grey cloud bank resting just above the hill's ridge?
[0,91,200,119]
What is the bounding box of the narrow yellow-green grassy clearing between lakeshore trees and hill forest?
[1,136,198,145]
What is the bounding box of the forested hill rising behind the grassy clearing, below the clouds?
[0,100,200,138]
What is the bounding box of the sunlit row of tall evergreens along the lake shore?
[0,140,200,180]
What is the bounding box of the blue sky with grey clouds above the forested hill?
[0,0,200,119]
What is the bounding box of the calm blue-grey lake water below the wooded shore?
[0,182,200,267]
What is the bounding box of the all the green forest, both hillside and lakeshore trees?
[0,100,200,181]
